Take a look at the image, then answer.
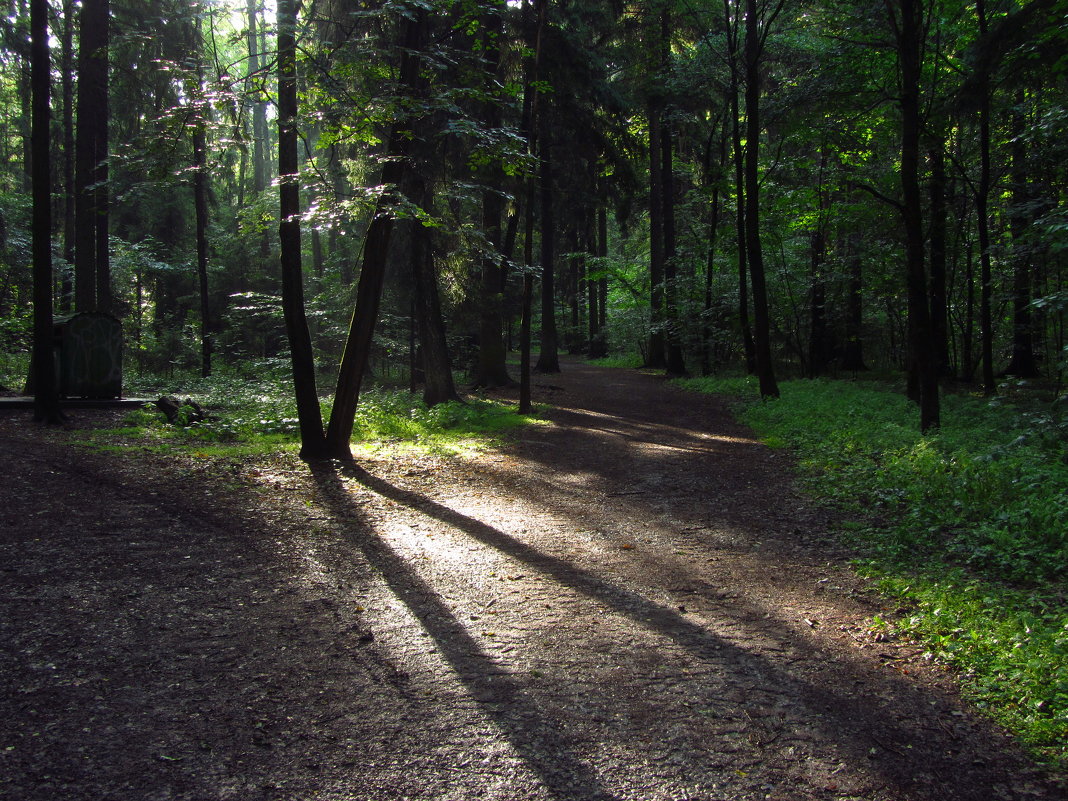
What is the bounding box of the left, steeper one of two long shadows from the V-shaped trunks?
[312,465,617,801]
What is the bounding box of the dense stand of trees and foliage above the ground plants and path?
[0,0,1068,440]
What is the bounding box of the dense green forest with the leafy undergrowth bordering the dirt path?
[0,0,1068,786]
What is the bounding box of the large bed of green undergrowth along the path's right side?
[682,378,1068,769]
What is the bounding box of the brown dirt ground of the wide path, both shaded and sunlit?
[0,363,1066,801]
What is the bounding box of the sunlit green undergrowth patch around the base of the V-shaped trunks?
[92,375,538,456]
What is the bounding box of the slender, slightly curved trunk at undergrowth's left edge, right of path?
[745,0,779,398]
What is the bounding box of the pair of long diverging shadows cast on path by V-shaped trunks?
[315,466,1050,801]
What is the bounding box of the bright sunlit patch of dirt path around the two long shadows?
[303,457,1008,801]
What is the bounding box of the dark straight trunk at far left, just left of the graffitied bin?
[30,0,63,424]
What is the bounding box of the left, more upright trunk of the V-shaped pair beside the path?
[278,0,328,459]
